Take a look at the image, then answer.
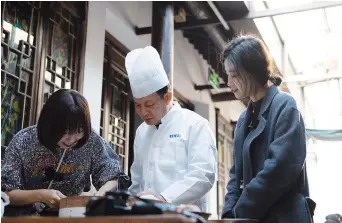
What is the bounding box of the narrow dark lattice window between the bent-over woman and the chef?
[100,34,130,173]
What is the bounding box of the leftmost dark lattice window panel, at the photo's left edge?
[1,2,41,156]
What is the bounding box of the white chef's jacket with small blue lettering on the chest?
[129,102,217,211]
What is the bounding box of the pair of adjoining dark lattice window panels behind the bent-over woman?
[1,1,86,158]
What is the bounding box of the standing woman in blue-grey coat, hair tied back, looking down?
[222,36,311,223]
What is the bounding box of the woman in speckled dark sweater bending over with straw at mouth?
[1,89,120,215]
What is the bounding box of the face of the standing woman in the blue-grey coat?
[224,60,251,99]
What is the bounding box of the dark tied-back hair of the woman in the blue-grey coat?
[222,35,282,86]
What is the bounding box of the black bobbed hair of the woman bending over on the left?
[37,89,91,152]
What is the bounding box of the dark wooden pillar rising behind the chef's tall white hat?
[151,1,174,94]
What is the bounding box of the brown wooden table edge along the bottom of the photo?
[1,214,196,223]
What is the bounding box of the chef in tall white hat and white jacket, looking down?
[125,46,217,211]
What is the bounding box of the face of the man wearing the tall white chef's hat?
[134,92,172,125]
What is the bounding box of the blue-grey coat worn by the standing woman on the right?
[222,86,311,223]
